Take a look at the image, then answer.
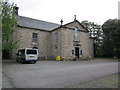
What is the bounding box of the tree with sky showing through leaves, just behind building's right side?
[81,20,103,56]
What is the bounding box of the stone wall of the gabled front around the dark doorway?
[62,22,94,59]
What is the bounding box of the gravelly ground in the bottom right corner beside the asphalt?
[68,74,120,88]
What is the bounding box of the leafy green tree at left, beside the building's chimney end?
[1,2,17,59]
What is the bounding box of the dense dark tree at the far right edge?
[102,19,120,58]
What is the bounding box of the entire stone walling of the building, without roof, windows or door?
[13,21,94,60]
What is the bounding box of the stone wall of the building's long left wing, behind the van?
[13,27,50,59]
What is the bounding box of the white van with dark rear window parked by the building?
[16,48,38,63]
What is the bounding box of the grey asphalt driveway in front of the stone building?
[2,59,118,88]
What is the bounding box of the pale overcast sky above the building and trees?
[9,0,119,25]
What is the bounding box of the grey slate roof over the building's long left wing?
[18,16,60,31]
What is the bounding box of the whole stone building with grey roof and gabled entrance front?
[13,6,94,59]
